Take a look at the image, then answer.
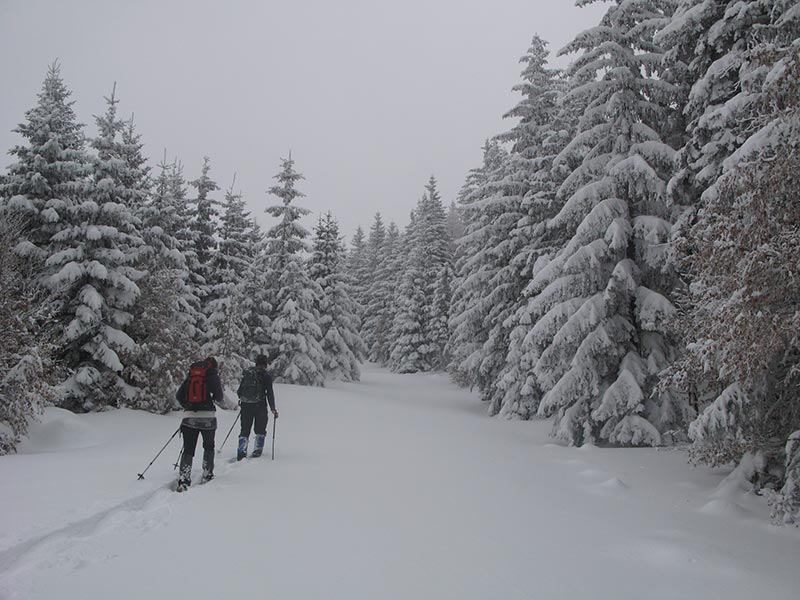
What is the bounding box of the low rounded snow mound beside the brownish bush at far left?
[18,406,100,454]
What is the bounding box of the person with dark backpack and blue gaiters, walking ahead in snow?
[236,354,278,460]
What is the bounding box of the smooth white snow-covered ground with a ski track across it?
[0,368,800,600]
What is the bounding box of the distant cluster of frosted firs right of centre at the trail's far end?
[347,176,463,373]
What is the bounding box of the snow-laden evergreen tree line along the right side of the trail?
[349,0,800,522]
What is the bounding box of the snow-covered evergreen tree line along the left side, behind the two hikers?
[0,64,364,454]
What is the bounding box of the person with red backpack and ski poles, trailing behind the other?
[175,356,223,492]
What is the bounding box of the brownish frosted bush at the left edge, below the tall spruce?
[0,214,58,455]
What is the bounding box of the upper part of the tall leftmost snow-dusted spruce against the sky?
[0,63,89,268]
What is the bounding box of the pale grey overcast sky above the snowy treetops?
[0,0,605,243]
